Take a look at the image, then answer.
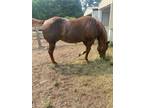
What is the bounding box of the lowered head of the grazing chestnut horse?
[97,41,109,58]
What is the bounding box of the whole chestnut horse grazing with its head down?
[33,16,109,64]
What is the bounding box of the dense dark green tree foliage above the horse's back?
[32,0,83,19]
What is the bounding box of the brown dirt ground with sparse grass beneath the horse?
[32,32,113,108]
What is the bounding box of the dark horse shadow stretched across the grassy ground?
[48,56,113,75]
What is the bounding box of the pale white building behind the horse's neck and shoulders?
[84,0,113,42]
